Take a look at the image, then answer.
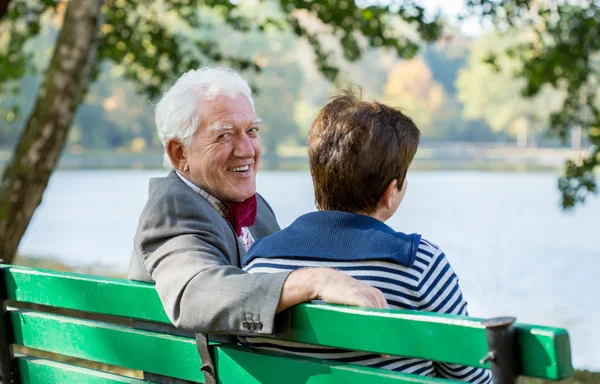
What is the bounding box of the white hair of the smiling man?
[154,67,254,169]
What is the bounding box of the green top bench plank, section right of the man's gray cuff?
[278,304,573,380]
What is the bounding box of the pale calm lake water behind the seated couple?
[20,170,600,370]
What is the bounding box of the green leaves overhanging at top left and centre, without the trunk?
[0,0,442,97]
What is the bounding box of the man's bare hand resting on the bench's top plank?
[277,268,389,312]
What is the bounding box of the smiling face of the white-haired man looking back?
[184,94,261,202]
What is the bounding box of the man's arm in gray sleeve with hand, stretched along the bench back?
[136,190,387,335]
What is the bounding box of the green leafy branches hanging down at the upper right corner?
[467,0,600,208]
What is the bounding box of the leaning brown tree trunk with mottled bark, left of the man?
[0,0,103,263]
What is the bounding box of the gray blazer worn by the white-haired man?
[129,172,289,336]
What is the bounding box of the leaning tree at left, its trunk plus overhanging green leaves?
[0,0,441,262]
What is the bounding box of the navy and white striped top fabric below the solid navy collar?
[243,239,491,384]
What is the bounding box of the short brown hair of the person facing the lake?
[308,91,420,214]
